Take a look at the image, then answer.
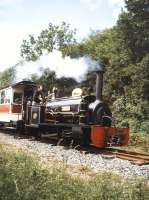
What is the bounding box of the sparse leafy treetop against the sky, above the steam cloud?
[21,22,76,61]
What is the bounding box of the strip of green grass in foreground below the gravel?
[0,148,149,200]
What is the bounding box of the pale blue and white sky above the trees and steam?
[0,0,124,71]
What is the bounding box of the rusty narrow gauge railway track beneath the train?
[0,129,149,166]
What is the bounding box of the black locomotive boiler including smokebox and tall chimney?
[46,71,112,127]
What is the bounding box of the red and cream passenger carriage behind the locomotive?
[0,81,36,126]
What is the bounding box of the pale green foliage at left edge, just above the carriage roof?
[0,67,16,88]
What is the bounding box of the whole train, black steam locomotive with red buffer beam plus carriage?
[0,71,129,148]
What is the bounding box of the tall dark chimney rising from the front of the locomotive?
[96,70,103,101]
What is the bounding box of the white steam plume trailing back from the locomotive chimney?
[16,50,100,81]
